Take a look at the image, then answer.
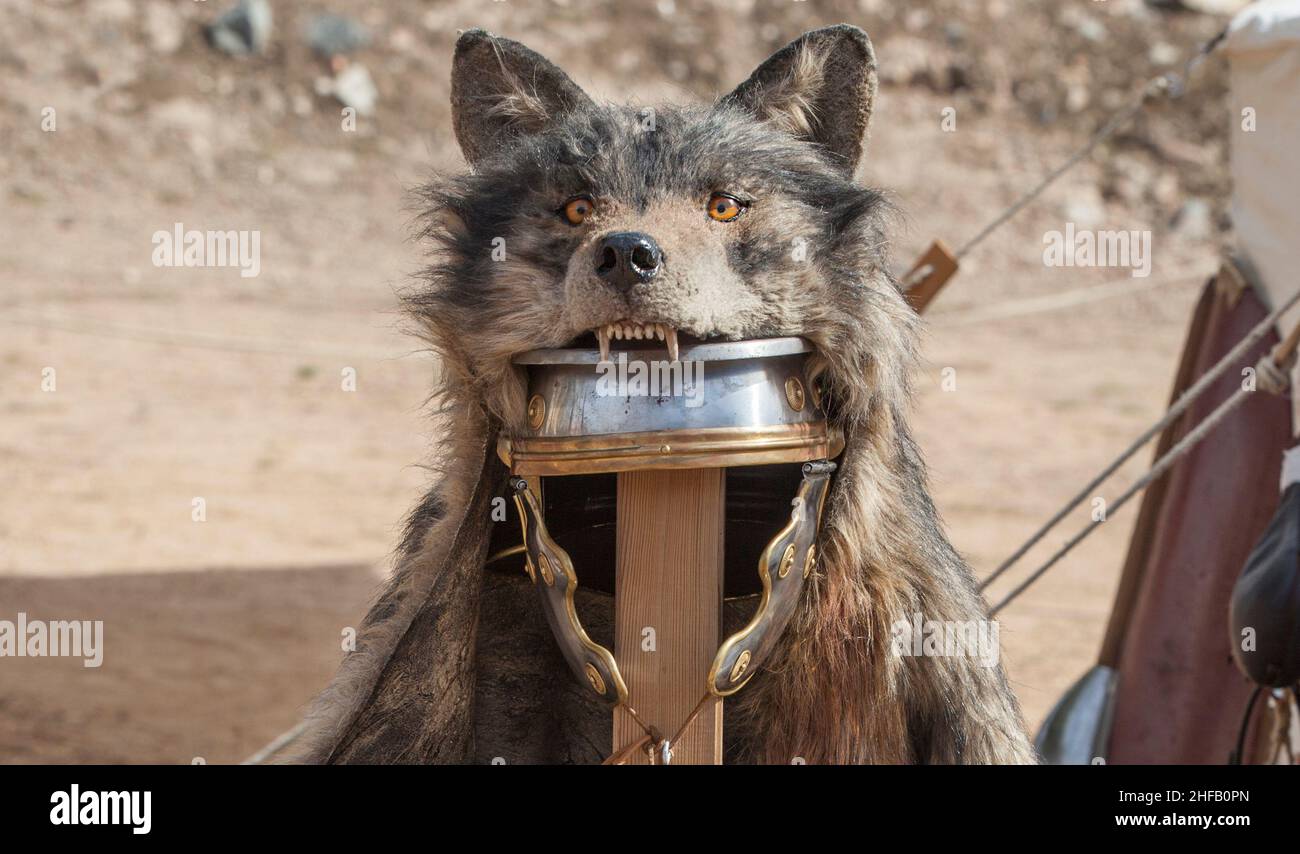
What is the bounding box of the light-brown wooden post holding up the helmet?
[614,468,727,764]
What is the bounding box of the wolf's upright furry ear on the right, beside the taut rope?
[723,23,876,174]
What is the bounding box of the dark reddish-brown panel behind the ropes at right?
[1108,281,1291,764]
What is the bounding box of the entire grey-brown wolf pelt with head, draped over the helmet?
[295,25,1034,763]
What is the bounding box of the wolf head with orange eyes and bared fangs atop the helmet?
[408,25,915,433]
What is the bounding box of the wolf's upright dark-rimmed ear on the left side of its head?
[451,30,592,165]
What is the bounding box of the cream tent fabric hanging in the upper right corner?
[1222,0,1300,425]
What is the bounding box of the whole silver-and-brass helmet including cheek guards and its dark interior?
[495,338,844,705]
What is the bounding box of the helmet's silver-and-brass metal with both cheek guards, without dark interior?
[498,338,844,706]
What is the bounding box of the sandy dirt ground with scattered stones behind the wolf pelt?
[0,0,1226,763]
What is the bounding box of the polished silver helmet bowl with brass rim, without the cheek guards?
[498,338,844,476]
